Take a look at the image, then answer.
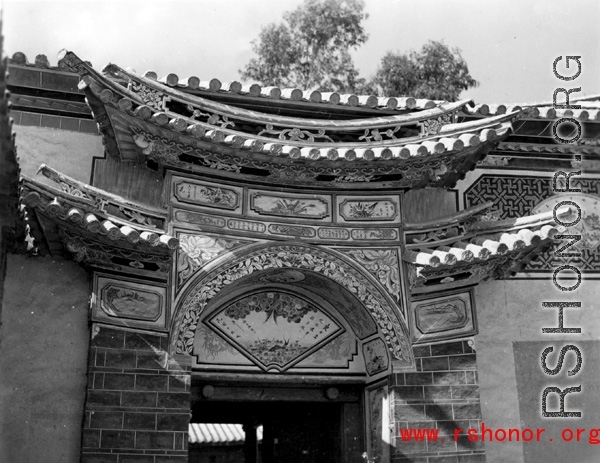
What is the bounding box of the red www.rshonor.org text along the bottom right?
[398,423,600,445]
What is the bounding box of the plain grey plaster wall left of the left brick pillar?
[0,254,90,463]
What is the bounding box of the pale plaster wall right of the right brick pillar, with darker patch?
[475,275,600,463]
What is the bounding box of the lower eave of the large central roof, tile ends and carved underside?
[101,105,511,188]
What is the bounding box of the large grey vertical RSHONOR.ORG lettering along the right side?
[540,56,583,418]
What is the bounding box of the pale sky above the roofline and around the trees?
[2,0,600,103]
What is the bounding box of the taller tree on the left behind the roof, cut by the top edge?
[240,0,368,92]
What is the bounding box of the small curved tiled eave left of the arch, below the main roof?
[21,177,179,254]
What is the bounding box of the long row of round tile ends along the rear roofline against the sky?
[9,52,600,121]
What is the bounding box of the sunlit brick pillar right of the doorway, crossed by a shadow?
[390,341,486,463]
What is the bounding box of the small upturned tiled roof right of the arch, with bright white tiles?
[404,203,574,291]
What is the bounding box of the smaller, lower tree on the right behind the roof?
[371,41,479,101]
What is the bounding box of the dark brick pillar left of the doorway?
[82,326,190,463]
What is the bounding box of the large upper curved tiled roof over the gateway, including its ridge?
[57,53,520,188]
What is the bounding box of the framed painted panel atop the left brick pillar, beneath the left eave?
[92,275,167,329]
